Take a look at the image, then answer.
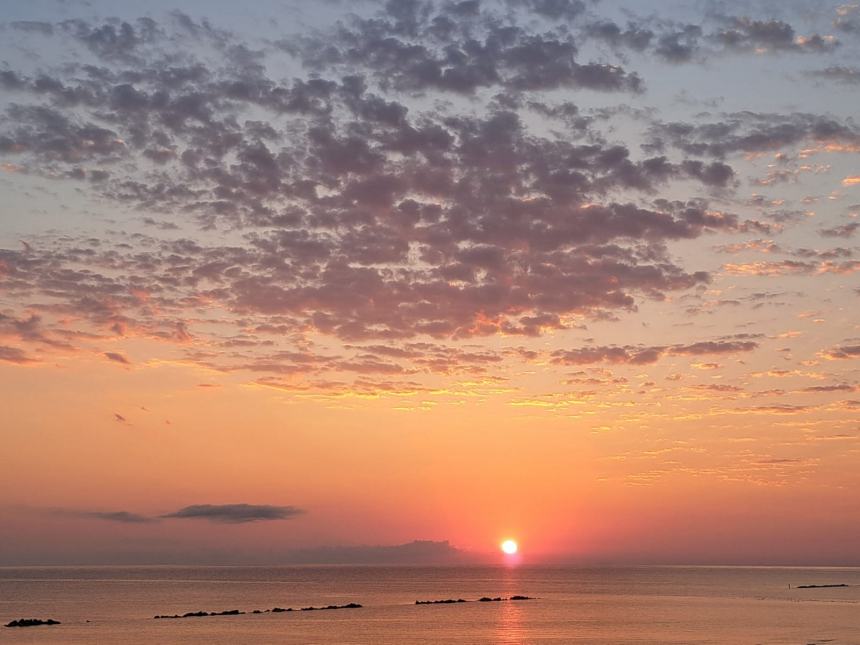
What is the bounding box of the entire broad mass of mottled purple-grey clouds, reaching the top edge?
[0,5,860,382]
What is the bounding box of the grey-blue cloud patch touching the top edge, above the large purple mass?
[280,0,642,94]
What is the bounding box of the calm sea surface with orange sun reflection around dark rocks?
[0,566,860,644]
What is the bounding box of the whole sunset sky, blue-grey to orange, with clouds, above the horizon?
[0,0,860,565]
